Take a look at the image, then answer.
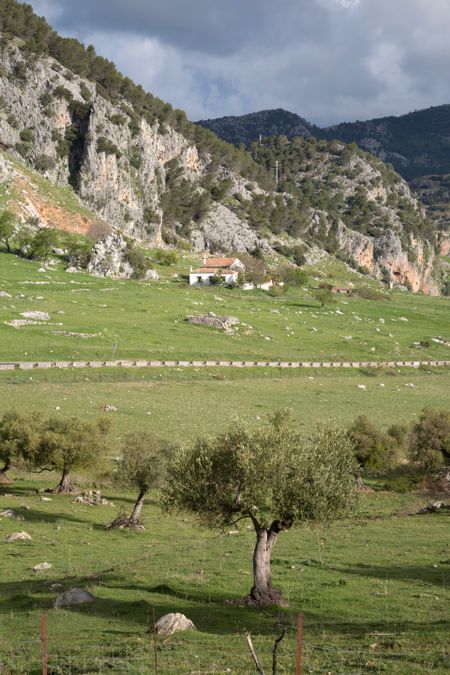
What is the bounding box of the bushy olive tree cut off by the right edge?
[409,408,450,476]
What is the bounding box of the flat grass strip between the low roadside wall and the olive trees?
[0,368,450,440]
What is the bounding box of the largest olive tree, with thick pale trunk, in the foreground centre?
[164,412,355,605]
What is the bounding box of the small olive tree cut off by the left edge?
[0,410,40,483]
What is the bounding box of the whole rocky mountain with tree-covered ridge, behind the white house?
[0,0,439,293]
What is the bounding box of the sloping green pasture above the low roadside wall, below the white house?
[0,254,450,360]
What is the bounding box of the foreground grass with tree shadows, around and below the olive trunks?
[0,476,450,675]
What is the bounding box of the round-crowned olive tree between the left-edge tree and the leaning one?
[31,417,110,494]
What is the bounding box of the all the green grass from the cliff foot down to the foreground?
[0,254,450,675]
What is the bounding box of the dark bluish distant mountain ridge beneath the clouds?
[198,105,450,180]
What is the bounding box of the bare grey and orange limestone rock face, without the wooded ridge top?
[0,39,438,292]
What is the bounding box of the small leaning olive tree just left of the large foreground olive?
[108,432,173,530]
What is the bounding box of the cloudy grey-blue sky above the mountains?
[28,0,450,126]
